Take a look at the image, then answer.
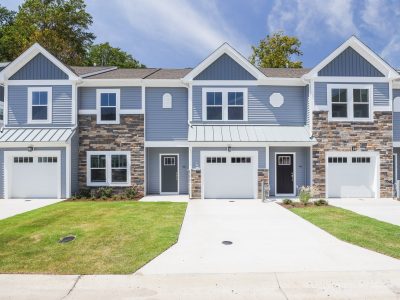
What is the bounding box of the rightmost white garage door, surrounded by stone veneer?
[326,152,378,198]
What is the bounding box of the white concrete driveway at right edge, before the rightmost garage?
[329,198,400,226]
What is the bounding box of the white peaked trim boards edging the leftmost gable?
[0,43,79,81]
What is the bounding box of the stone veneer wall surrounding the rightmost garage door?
[312,112,393,198]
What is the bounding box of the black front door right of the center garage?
[276,154,294,195]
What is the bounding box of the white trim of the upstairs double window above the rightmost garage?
[326,84,374,122]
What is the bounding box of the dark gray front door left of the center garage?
[161,155,178,193]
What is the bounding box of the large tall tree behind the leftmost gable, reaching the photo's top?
[0,0,95,65]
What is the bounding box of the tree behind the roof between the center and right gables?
[250,31,303,68]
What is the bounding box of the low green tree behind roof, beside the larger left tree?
[85,43,146,68]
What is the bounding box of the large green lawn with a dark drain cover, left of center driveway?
[0,202,186,274]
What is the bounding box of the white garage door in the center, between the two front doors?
[202,152,257,199]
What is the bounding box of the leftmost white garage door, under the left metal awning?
[7,152,61,198]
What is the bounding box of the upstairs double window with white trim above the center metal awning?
[202,88,247,121]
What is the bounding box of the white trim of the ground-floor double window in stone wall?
[86,151,131,187]
